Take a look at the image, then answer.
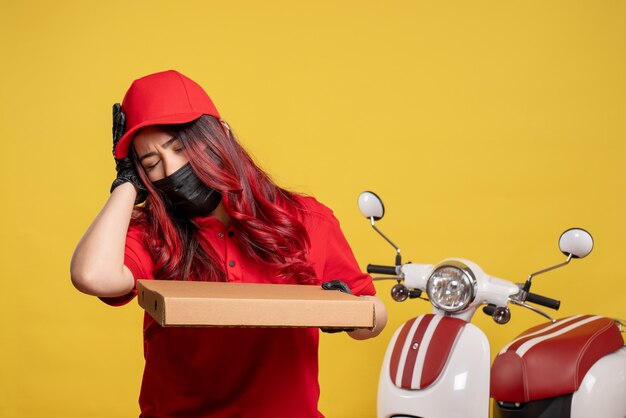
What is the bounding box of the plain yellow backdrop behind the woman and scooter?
[0,0,626,418]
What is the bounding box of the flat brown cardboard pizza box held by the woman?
[137,280,375,328]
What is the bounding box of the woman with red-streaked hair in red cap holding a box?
[71,71,386,418]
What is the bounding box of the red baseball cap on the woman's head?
[115,70,220,159]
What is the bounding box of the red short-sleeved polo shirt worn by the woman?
[104,197,375,418]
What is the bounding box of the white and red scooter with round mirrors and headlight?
[358,192,626,418]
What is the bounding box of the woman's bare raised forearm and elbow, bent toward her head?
[70,183,137,297]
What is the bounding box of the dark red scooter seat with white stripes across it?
[491,315,624,402]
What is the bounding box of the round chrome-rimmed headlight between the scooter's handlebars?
[426,260,476,312]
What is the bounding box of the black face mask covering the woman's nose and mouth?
[152,163,222,218]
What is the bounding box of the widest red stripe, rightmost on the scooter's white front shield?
[420,317,467,389]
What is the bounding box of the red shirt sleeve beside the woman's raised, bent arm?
[100,224,154,306]
